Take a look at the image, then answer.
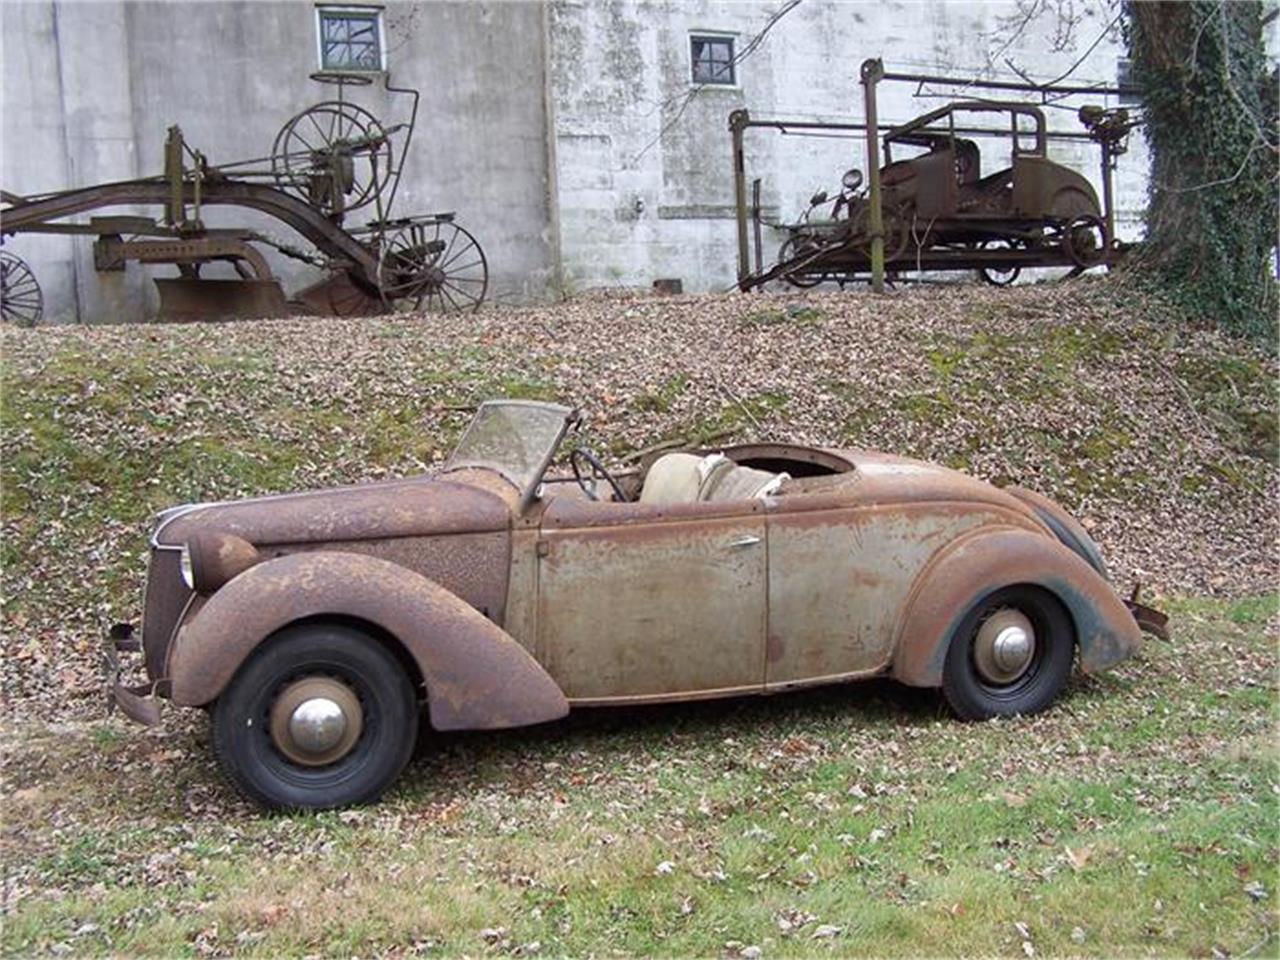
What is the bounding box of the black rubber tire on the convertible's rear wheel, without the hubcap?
[942,585,1075,719]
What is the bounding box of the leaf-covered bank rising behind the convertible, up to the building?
[0,282,1280,716]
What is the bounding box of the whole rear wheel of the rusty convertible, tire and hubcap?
[942,586,1075,719]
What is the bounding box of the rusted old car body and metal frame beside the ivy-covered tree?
[730,60,1137,291]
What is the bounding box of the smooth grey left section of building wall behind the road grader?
[0,0,554,323]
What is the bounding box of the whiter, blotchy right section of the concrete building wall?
[548,0,1147,291]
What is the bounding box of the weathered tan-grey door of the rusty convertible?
[538,498,767,703]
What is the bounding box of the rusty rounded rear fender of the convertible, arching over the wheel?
[892,526,1142,686]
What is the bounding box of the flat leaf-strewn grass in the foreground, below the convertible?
[0,595,1280,956]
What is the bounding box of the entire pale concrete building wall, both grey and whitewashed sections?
[0,0,1277,321]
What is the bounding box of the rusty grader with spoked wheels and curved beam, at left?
[0,73,489,325]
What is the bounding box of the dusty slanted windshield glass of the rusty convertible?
[445,401,575,494]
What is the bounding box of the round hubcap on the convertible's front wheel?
[270,677,364,767]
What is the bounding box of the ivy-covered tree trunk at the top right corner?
[1125,0,1280,346]
